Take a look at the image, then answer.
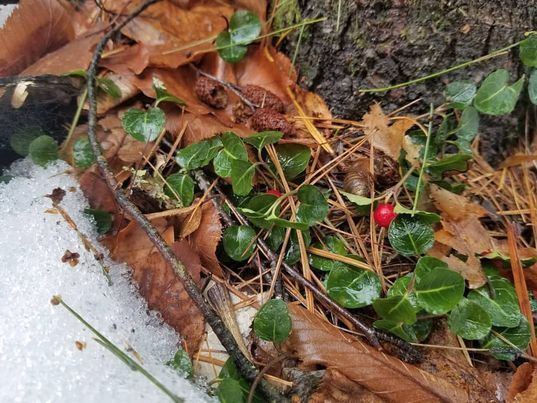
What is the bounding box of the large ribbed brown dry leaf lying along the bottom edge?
[286,305,469,402]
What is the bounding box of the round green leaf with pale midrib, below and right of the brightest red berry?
[416,268,465,315]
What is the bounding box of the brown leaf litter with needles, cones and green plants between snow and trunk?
[0,0,537,401]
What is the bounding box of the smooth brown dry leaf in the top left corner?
[0,0,75,77]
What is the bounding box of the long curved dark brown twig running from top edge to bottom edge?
[87,0,287,401]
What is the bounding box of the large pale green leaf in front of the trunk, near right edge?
[474,69,524,115]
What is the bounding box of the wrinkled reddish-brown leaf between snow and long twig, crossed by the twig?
[103,219,205,353]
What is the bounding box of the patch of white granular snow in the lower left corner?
[0,161,210,402]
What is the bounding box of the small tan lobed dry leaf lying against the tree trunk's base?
[361,103,414,161]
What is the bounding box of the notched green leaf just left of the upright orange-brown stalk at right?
[468,277,520,327]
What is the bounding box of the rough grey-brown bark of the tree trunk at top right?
[276,0,537,160]
